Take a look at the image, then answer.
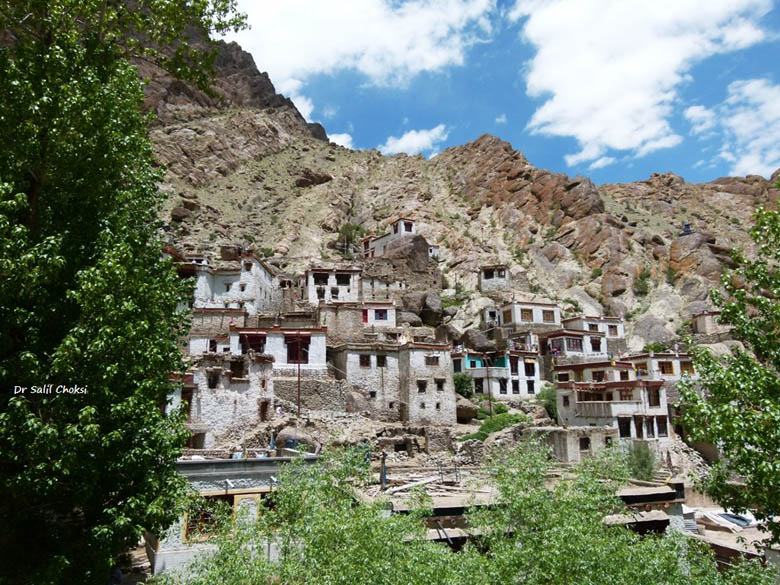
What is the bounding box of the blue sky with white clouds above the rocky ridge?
[227,0,780,183]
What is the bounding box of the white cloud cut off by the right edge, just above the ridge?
[717,79,780,177]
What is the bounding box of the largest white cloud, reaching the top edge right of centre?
[509,0,772,168]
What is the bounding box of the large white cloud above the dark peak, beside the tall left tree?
[229,0,495,90]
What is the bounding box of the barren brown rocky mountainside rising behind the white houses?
[141,44,780,349]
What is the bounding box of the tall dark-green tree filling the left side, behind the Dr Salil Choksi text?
[0,0,244,583]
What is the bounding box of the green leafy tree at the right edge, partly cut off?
[681,208,780,542]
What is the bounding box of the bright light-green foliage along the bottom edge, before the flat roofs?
[156,442,771,585]
